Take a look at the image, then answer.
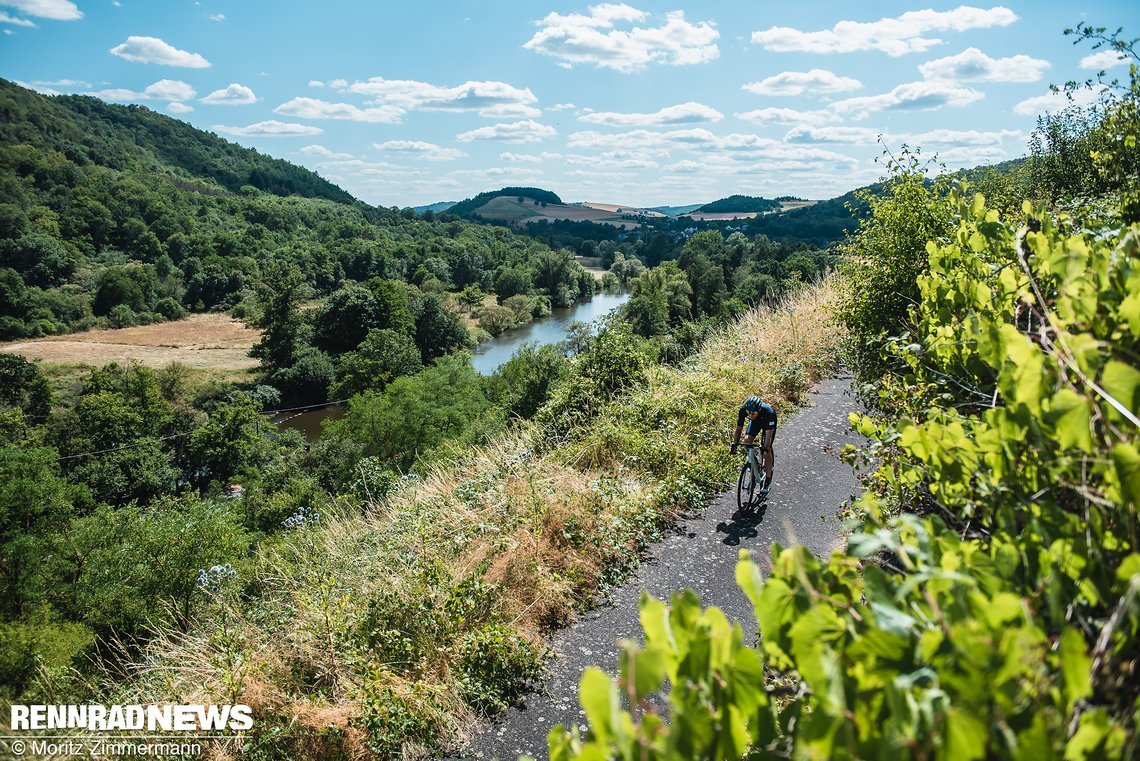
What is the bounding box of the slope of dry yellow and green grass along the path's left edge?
[124,284,839,758]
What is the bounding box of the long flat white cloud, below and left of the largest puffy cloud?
[332,76,539,118]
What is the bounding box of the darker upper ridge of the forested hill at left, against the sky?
[0,80,356,203]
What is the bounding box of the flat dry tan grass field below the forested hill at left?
[0,314,261,371]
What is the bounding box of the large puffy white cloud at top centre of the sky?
[522,3,720,72]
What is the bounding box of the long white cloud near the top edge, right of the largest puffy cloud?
[752,6,1017,56]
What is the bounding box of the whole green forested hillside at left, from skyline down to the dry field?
[0,81,593,341]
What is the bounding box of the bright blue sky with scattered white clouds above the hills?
[0,0,1140,206]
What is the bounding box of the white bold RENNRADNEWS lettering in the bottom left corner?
[11,704,253,733]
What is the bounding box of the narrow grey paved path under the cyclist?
[462,377,857,761]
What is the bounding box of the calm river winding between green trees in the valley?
[270,293,629,444]
